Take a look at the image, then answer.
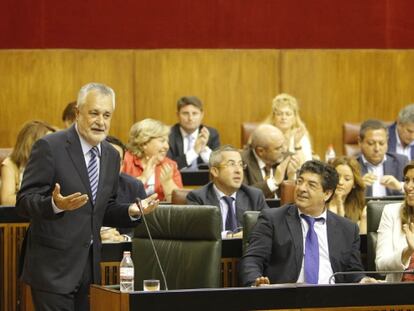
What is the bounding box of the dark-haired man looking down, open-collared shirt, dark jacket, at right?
[358,120,408,197]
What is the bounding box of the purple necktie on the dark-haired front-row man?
[300,214,323,284]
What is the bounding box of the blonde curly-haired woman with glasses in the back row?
[264,93,312,163]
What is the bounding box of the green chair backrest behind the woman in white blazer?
[367,200,402,271]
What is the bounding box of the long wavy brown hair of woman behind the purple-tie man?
[331,156,365,222]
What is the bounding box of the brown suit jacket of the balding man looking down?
[241,147,275,198]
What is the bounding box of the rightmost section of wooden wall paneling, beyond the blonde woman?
[281,50,414,157]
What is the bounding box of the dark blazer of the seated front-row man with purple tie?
[239,204,364,286]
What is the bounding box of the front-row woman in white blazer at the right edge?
[375,161,414,282]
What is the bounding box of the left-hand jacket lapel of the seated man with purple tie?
[286,205,303,275]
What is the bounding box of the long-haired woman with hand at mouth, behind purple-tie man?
[328,156,367,234]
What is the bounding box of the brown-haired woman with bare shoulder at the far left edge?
[0,120,55,205]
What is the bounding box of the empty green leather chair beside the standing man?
[132,205,222,290]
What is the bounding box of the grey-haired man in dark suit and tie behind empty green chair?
[187,145,268,237]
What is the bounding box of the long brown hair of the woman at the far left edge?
[10,120,55,168]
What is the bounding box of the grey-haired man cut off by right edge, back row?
[388,104,414,161]
